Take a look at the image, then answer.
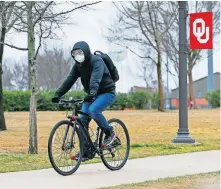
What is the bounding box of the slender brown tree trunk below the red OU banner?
[188,53,196,108]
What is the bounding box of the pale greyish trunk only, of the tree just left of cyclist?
[26,1,38,154]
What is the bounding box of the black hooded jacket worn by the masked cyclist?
[56,41,116,97]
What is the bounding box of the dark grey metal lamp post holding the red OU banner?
[172,1,195,143]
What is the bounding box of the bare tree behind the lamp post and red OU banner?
[163,1,220,105]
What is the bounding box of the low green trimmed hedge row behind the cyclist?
[3,90,158,111]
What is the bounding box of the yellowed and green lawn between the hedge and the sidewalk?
[0,109,220,172]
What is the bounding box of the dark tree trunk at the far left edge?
[0,2,7,131]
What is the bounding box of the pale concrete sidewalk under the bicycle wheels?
[0,150,220,189]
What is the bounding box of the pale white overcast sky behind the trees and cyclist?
[4,2,220,92]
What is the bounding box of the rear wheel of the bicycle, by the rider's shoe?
[99,119,130,171]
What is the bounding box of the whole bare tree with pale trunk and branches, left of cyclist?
[4,1,99,154]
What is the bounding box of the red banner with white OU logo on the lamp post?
[190,12,213,49]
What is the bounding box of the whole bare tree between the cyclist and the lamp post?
[109,1,177,111]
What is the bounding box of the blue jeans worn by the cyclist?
[81,93,116,135]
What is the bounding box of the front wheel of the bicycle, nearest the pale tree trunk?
[48,120,83,176]
